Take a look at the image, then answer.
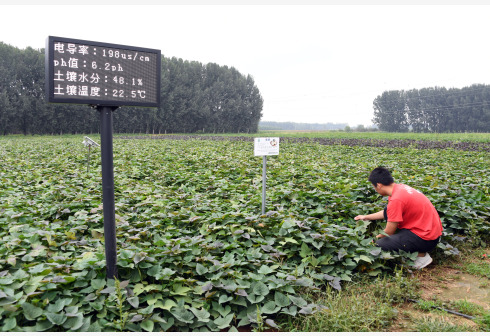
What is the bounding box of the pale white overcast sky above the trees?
[0,0,490,126]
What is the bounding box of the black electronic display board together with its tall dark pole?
[45,36,161,279]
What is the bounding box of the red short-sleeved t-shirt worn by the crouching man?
[387,184,442,240]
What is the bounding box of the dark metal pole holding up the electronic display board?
[97,106,117,279]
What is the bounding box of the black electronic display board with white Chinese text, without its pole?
[45,36,161,107]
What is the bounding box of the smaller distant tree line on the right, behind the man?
[372,84,490,133]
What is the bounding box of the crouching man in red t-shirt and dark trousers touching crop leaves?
[354,167,442,269]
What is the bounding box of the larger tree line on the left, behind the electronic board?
[0,42,263,135]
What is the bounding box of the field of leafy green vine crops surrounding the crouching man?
[0,135,490,332]
